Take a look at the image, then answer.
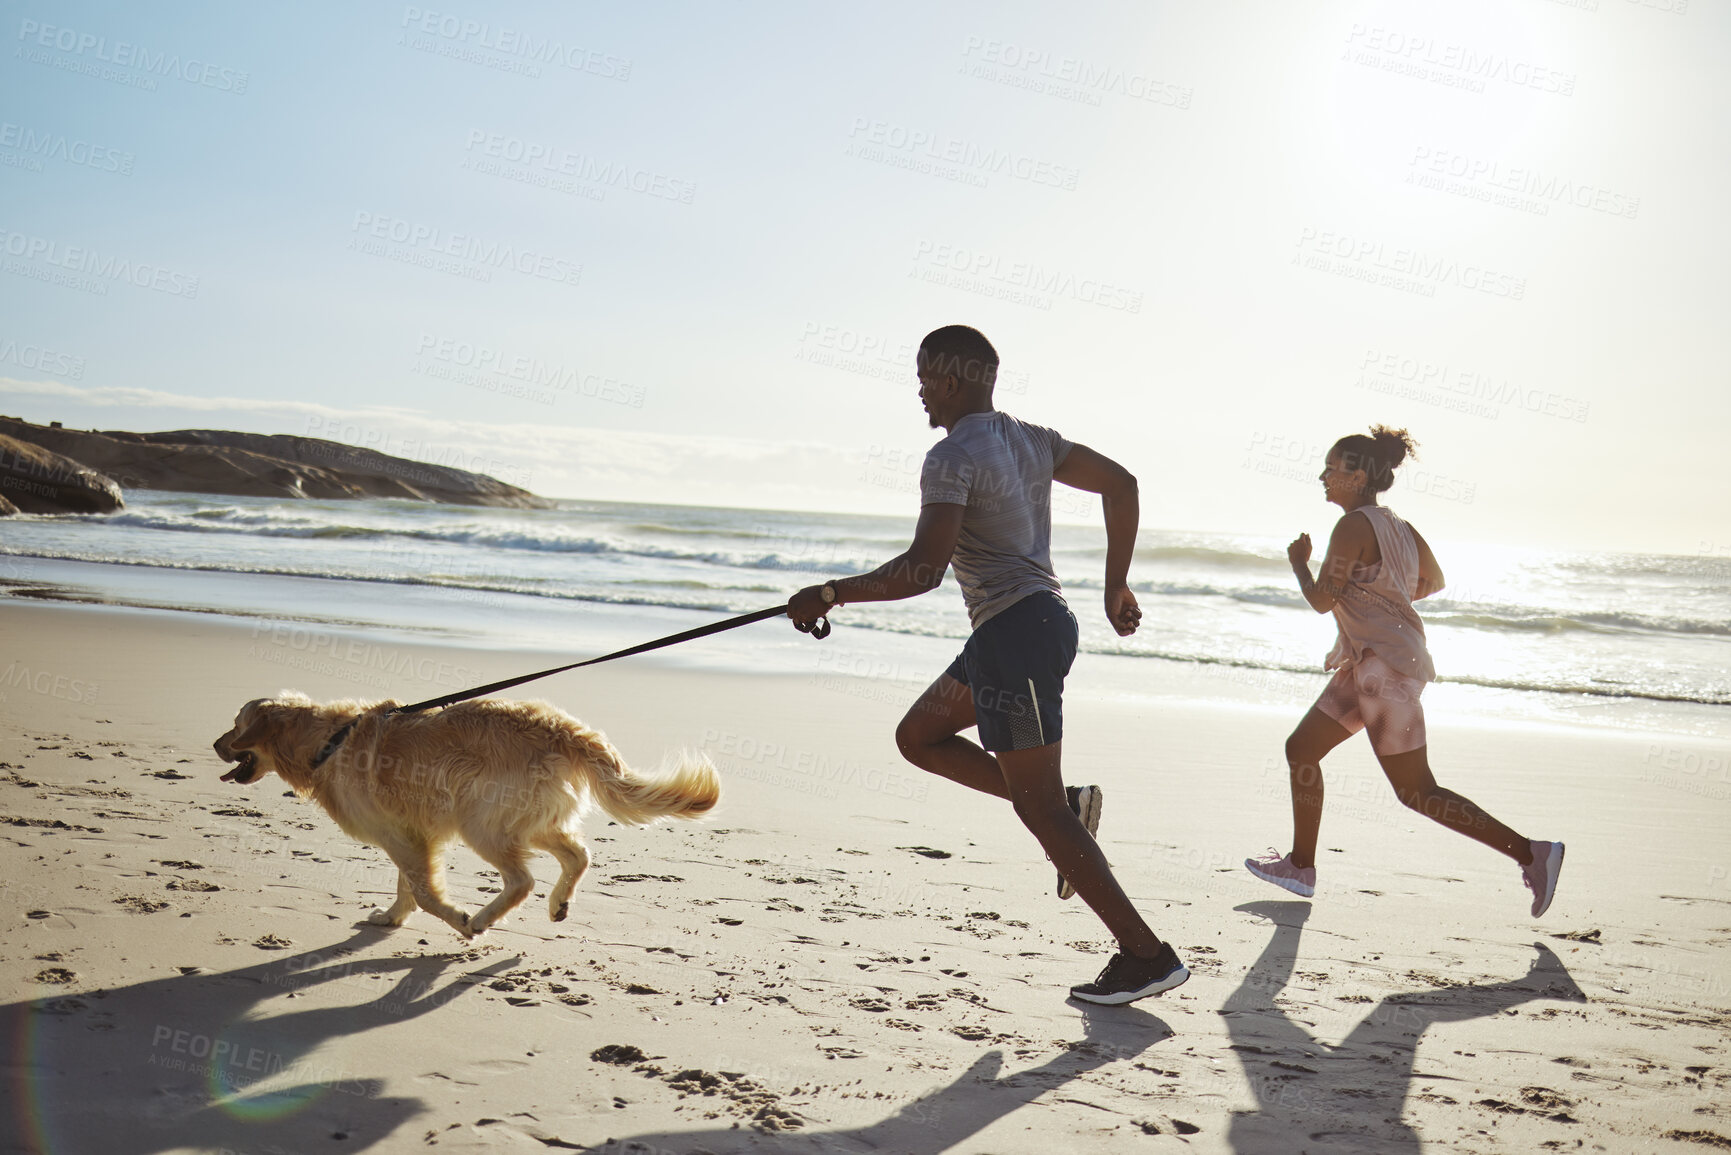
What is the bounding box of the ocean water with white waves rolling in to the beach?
[0,492,1731,729]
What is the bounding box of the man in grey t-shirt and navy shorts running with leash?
[788,326,1189,1003]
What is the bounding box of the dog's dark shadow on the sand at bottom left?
[0,930,516,1155]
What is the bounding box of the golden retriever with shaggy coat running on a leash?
[215,691,722,939]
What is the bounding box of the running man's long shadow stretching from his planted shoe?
[587,1003,1172,1155]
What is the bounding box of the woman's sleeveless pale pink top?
[1324,506,1437,682]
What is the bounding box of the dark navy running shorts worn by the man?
[945,592,1077,752]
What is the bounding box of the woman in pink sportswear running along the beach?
[1245,426,1563,918]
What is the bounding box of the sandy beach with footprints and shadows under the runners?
[0,599,1731,1155]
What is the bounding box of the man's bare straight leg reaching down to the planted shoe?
[997,741,1160,959]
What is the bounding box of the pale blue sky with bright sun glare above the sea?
[0,0,1731,552]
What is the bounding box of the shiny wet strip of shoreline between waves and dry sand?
[0,558,1731,746]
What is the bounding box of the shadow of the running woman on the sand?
[1220,900,1587,1155]
